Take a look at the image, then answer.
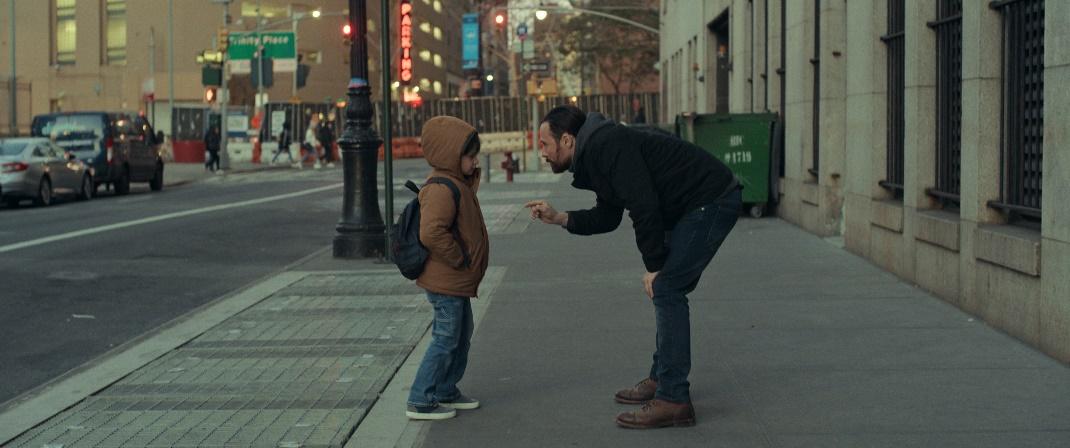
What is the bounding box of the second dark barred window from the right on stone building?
[927,0,962,207]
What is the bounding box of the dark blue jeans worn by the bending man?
[651,189,743,403]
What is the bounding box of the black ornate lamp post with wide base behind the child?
[334,0,385,259]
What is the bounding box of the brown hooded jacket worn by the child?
[416,117,490,297]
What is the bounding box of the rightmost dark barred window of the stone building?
[990,0,1044,221]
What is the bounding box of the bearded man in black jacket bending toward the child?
[525,106,742,429]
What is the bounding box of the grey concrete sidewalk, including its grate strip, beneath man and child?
[0,173,1070,447]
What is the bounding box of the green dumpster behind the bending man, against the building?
[676,113,778,218]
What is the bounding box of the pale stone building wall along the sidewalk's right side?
[661,0,1070,362]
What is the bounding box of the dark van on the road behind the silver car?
[31,112,164,195]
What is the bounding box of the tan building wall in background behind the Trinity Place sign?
[0,0,460,132]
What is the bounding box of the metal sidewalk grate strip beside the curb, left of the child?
[9,273,431,448]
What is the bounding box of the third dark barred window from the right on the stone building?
[881,0,906,199]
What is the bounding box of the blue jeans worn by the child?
[408,291,474,407]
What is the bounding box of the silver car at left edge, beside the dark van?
[0,137,93,207]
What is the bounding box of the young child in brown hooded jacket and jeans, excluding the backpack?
[406,117,490,420]
